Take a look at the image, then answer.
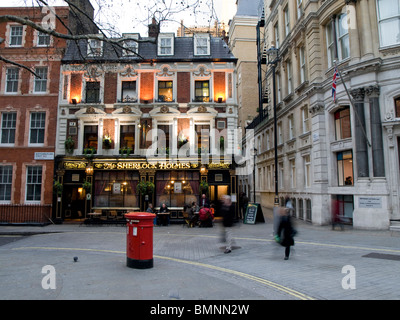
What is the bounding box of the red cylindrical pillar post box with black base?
[125,212,156,269]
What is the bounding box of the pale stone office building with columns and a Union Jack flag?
[250,0,400,229]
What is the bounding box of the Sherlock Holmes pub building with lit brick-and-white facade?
[53,21,237,222]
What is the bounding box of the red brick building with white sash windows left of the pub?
[0,1,93,223]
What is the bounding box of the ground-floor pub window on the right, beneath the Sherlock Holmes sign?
[155,171,200,207]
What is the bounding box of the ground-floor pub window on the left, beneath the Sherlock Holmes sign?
[94,171,139,208]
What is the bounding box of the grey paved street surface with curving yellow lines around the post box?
[0,212,400,301]
